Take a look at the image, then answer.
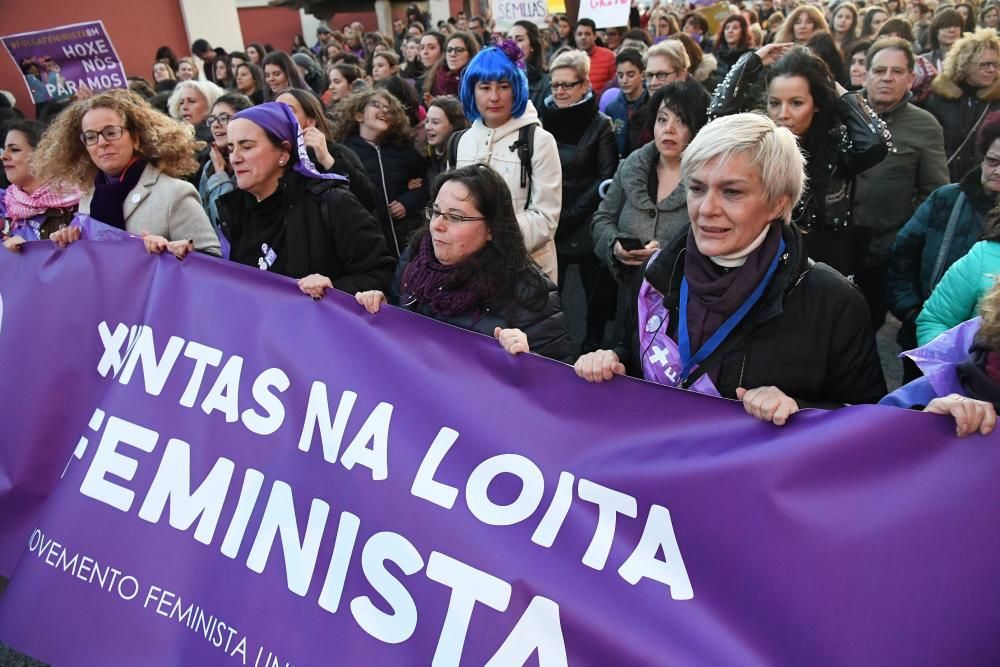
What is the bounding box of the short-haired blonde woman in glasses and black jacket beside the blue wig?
[541,51,618,352]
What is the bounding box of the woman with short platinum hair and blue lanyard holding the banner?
[575,113,885,426]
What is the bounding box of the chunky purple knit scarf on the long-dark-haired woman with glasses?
[400,234,489,318]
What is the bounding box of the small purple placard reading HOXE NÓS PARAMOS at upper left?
[0,21,127,104]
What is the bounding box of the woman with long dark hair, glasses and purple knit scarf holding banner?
[355,164,573,362]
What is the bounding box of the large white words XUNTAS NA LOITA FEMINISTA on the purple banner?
[60,322,694,665]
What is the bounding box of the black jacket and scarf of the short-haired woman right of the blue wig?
[541,95,618,256]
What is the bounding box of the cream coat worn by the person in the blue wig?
[457,102,562,282]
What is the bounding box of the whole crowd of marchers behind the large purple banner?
[0,0,1000,434]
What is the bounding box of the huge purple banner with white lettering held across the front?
[0,240,1000,667]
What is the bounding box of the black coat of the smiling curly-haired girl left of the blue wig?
[344,134,430,257]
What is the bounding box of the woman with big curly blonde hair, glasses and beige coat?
[32,90,220,258]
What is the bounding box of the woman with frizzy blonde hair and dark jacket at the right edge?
[926,29,1000,183]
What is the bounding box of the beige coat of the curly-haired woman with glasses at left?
[80,164,222,257]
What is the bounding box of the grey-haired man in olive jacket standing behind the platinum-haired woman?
[851,37,949,330]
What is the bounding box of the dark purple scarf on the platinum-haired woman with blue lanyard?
[684,221,782,354]
